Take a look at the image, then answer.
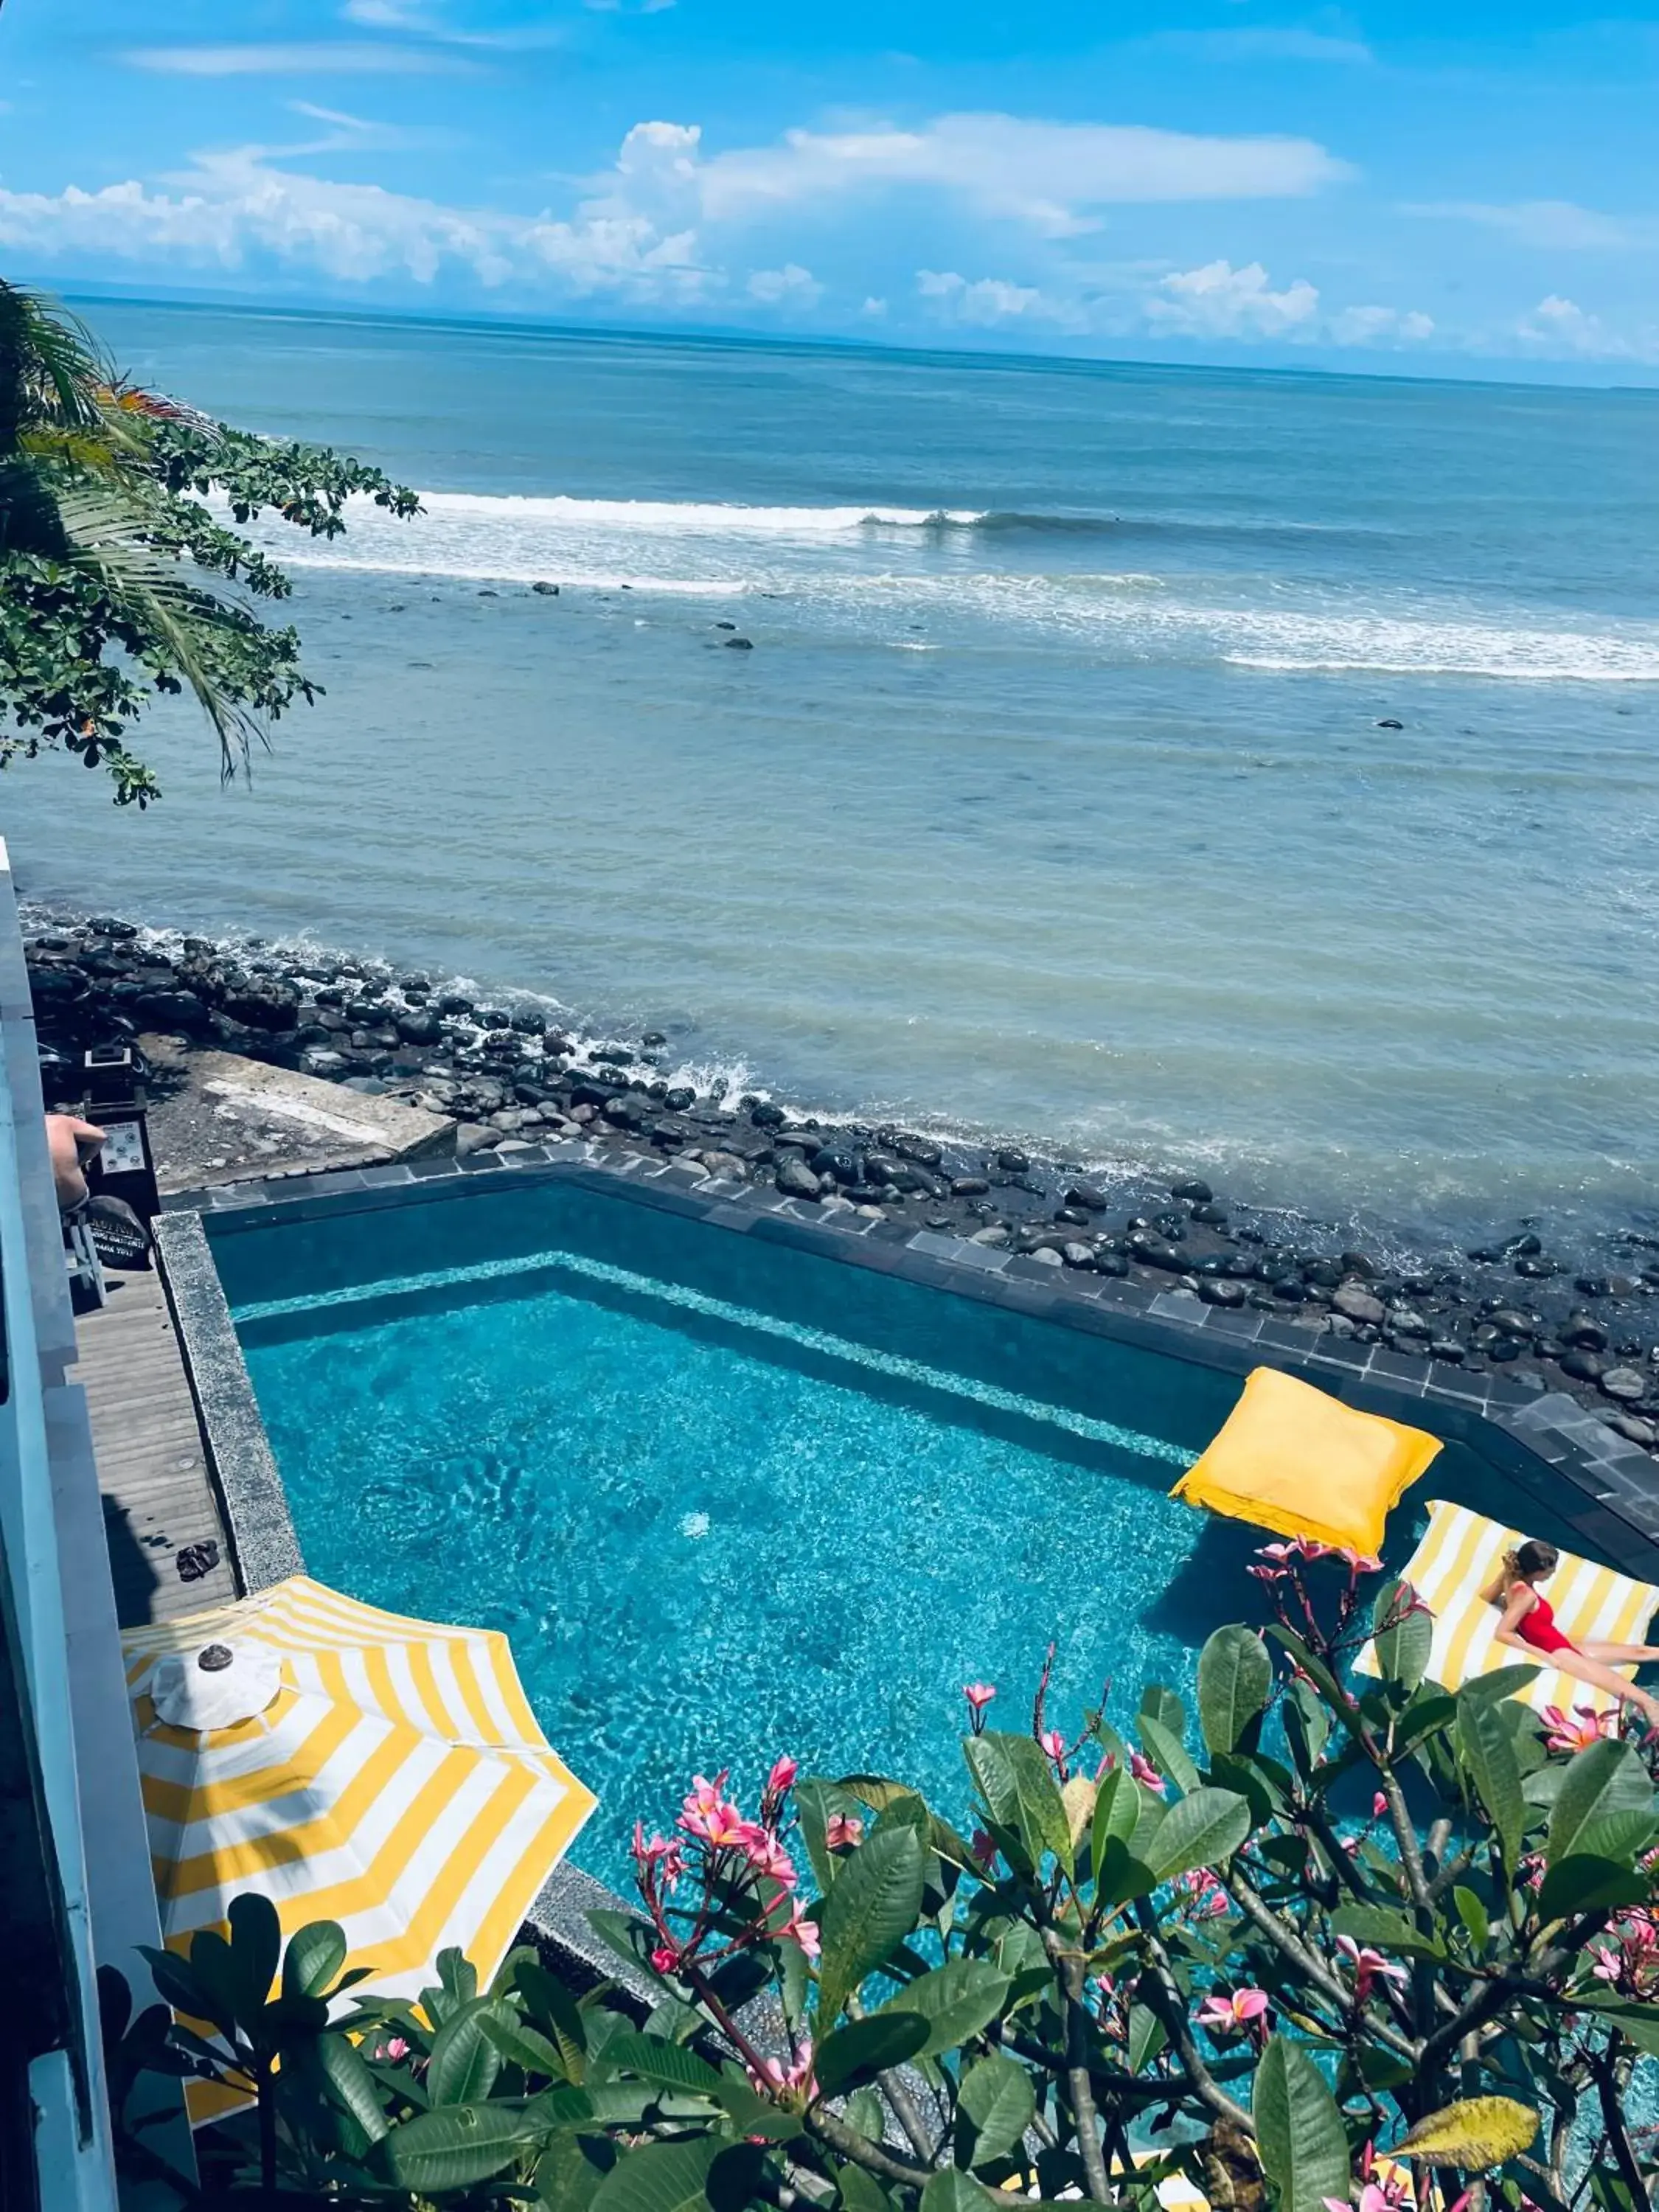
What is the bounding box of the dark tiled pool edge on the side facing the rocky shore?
[164,1141,1659,1582]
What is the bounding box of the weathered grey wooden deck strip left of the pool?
[73,1272,237,1628]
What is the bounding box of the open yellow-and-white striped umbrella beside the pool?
[122,1575,595,2117]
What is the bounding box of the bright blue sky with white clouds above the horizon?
[0,0,1659,383]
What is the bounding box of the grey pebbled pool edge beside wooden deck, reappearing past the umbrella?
[155,1206,641,2020]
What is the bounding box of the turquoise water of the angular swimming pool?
[212,1183,1593,1887]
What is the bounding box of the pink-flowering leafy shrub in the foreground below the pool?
[106,1546,1659,2212]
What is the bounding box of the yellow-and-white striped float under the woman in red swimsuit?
[1354,1498,1659,1712]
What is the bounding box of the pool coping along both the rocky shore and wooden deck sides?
[157,1139,1659,1588]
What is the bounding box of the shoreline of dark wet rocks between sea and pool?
[27,914,1659,1455]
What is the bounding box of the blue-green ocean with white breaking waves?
[0,301,1659,1248]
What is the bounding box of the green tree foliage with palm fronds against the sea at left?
[0,281,418,807]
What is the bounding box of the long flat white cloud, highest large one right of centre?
[701,115,1352,237]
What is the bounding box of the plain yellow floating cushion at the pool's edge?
[1170,1367,1440,1557]
